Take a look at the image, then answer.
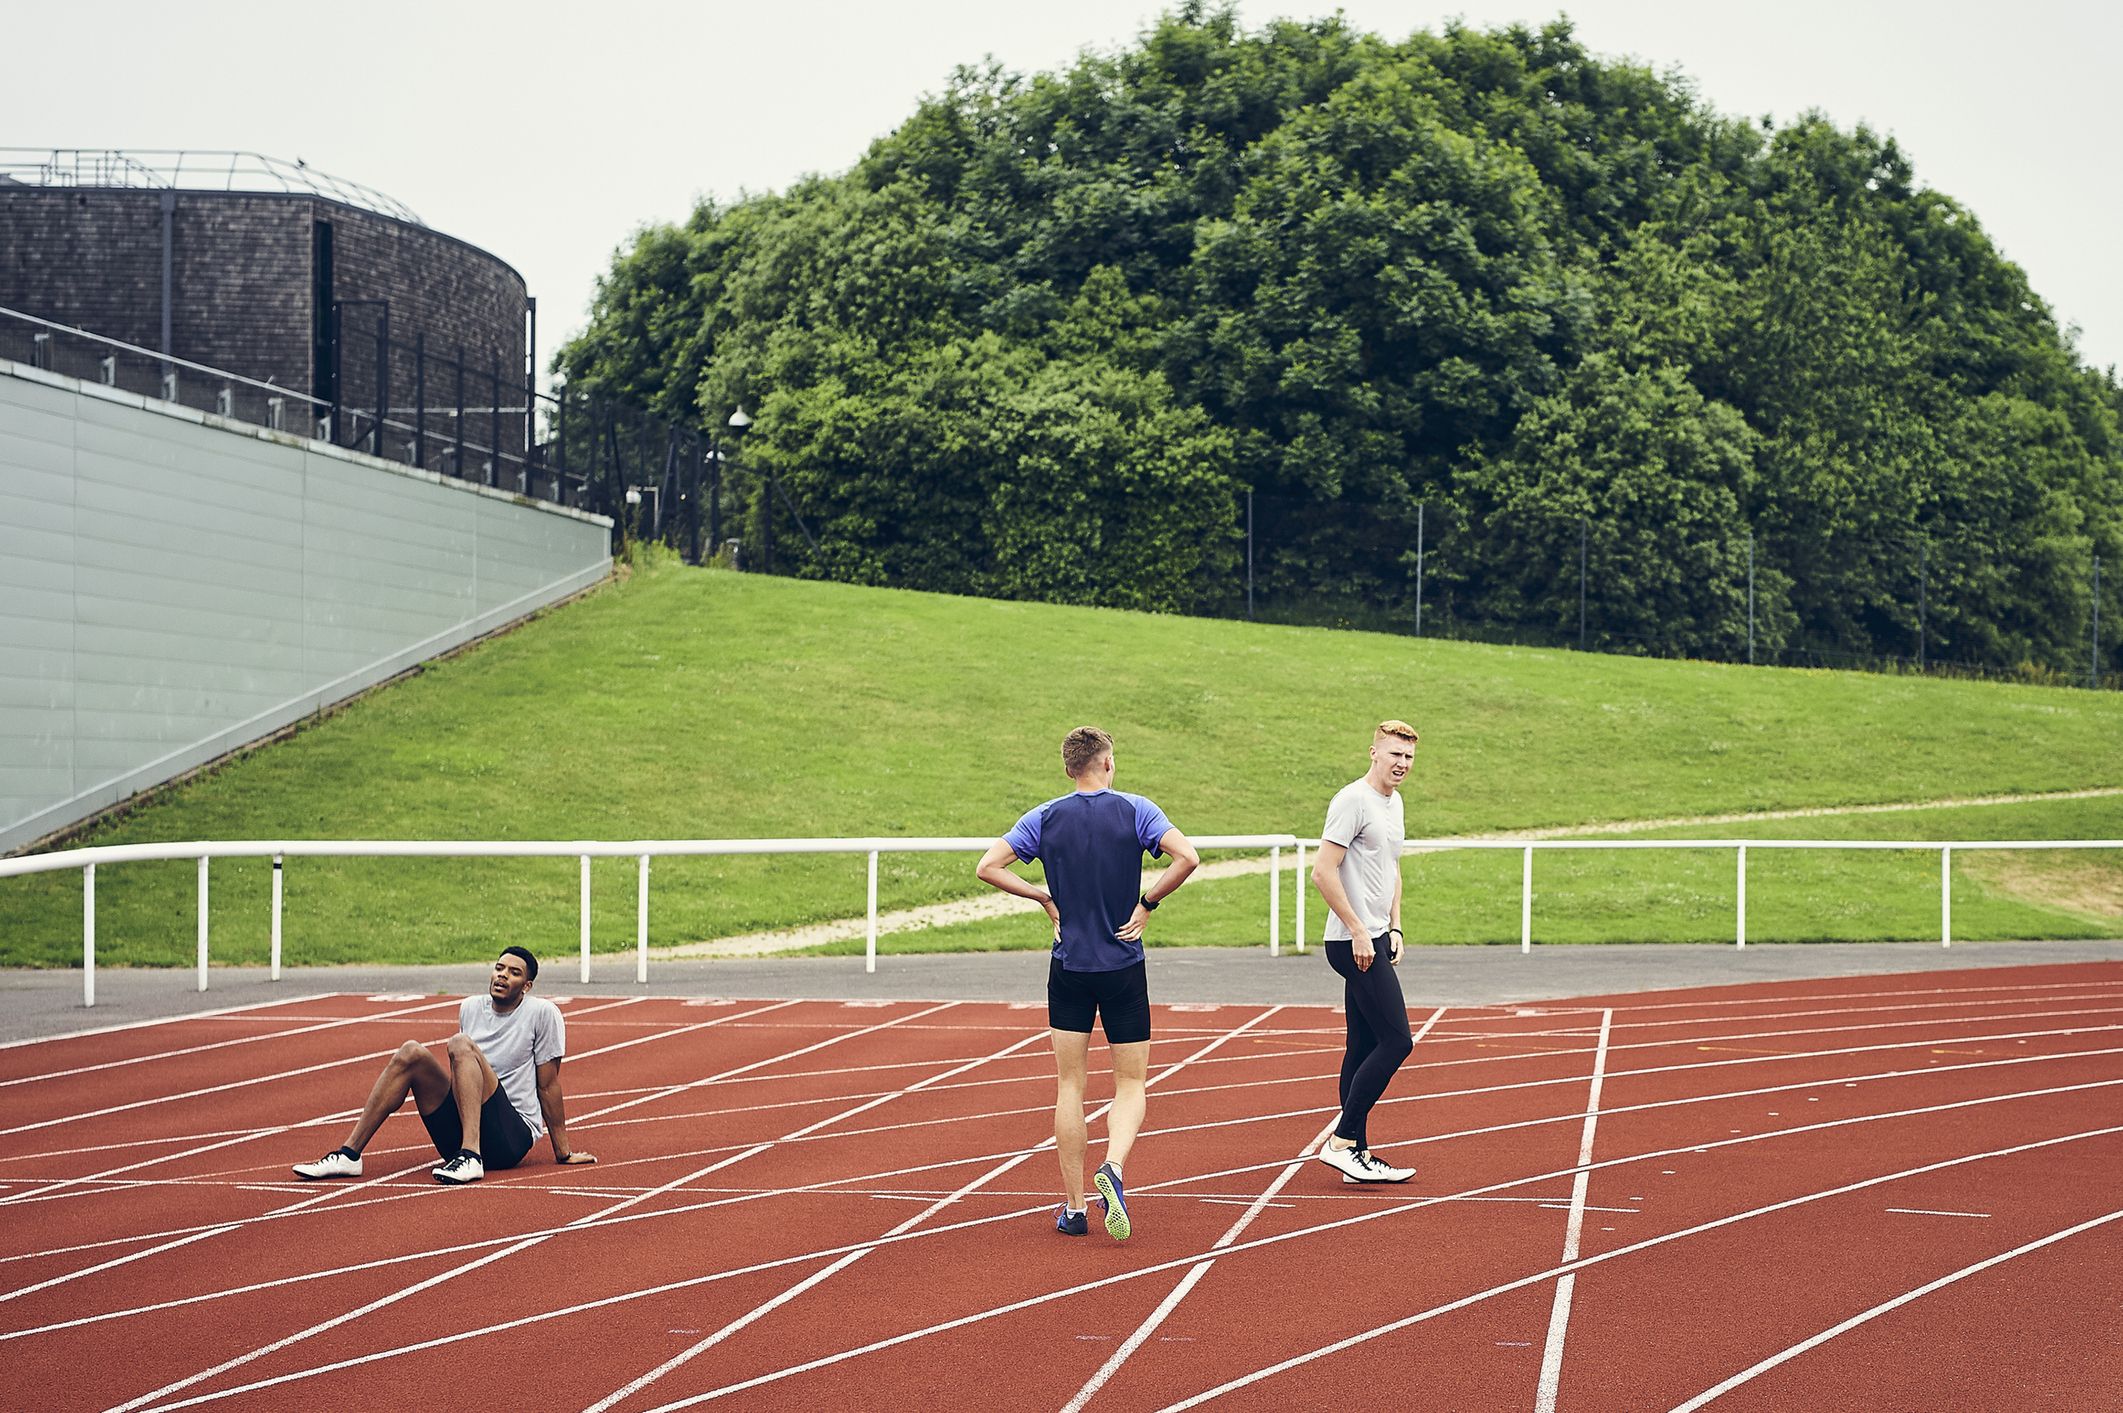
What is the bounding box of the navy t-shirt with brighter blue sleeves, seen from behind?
[1002,789,1172,972]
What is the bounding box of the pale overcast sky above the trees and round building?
[0,0,2123,379]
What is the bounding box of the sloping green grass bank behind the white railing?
[12,560,2123,965]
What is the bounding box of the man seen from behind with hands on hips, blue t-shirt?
[974,726,1202,1241]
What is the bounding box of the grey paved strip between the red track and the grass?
[0,940,2123,1042]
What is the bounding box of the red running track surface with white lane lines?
[0,963,2123,1413]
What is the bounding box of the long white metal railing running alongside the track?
[0,834,2123,1006]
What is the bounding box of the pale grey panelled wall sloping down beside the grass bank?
[0,361,611,851]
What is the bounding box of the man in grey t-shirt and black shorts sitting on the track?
[295,946,597,1186]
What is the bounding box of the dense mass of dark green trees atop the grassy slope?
[558,4,2123,666]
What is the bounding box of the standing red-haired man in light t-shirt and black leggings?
[1312,721,1418,1182]
